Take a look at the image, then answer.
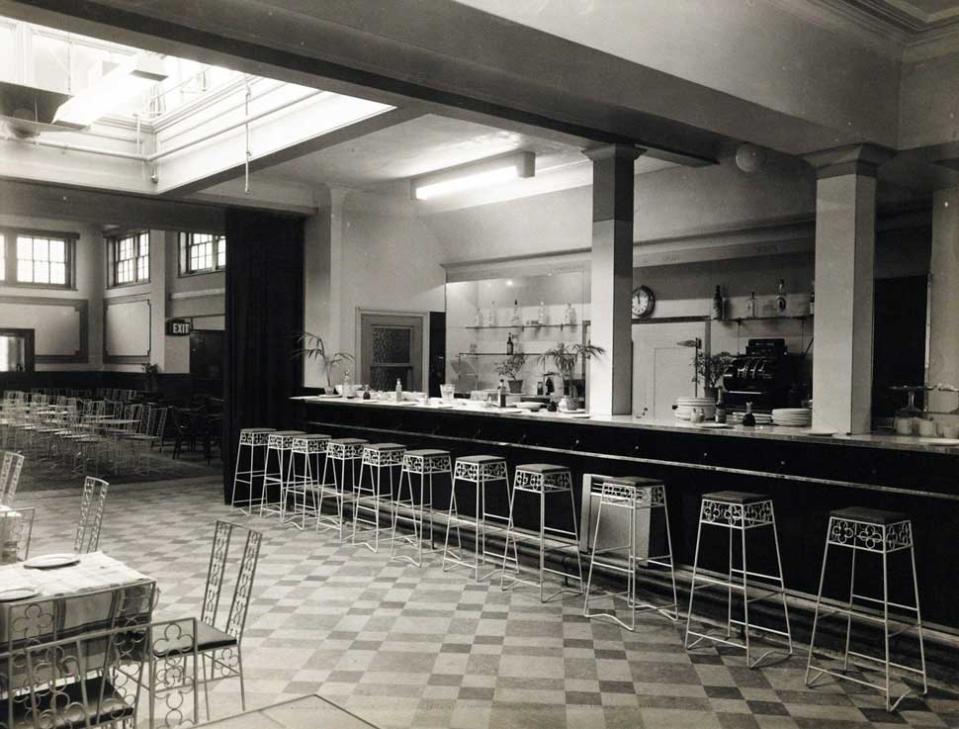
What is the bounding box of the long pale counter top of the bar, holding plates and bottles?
[293,395,959,455]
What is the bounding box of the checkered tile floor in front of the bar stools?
[18,478,959,729]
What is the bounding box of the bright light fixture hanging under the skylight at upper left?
[53,54,167,127]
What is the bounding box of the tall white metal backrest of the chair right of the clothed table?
[201,520,263,641]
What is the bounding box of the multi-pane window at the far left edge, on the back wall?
[0,229,75,288]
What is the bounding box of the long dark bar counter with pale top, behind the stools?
[296,397,959,634]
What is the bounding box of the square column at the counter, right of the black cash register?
[807,145,888,433]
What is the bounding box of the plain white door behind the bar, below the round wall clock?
[633,320,709,420]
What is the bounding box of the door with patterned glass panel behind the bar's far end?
[356,314,423,391]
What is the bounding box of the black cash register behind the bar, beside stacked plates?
[723,339,806,412]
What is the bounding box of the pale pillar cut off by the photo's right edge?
[926,187,959,412]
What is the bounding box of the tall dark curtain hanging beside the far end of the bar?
[223,208,303,501]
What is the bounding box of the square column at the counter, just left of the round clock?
[585,144,642,415]
